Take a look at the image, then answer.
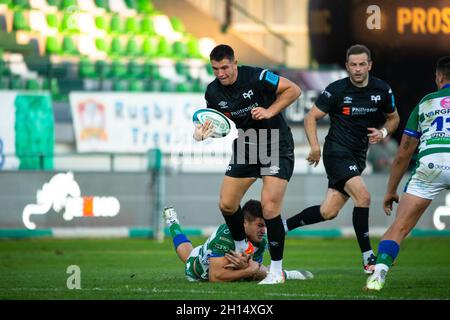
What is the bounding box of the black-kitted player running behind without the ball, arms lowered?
[286,45,399,274]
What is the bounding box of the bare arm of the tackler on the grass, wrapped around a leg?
[209,257,259,282]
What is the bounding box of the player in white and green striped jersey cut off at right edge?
[366,56,450,290]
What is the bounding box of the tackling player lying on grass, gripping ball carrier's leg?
[164,200,313,282]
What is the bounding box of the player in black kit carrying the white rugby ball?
[194,44,301,284]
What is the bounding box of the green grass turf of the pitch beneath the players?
[0,237,450,300]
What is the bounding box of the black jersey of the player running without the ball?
[316,75,395,153]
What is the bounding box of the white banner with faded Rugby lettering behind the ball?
[70,92,237,154]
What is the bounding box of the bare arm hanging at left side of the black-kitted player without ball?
[304,104,327,167]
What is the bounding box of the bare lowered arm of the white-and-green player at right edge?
[383,134,419,215]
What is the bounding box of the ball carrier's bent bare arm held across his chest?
[251,77,302,120]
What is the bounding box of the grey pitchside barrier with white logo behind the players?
[0,168,450,240]
